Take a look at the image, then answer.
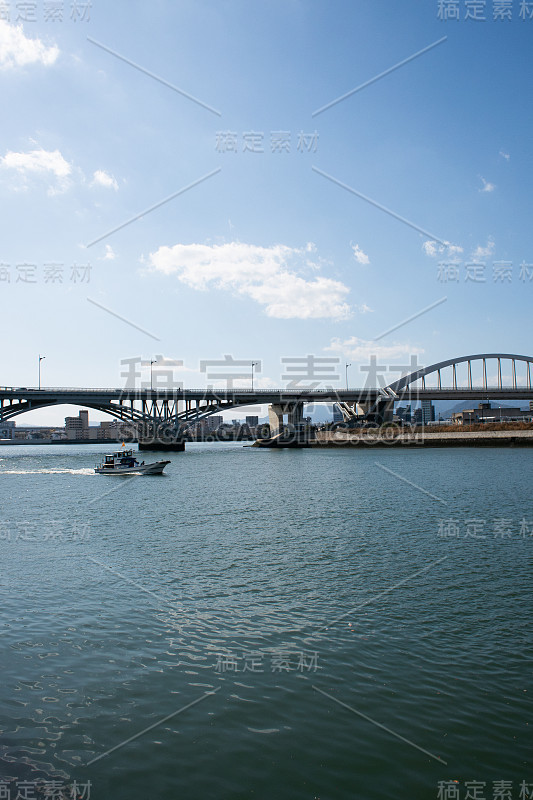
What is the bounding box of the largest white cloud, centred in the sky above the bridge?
[150,242,352,320]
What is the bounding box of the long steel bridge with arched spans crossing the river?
[0,353,533,449]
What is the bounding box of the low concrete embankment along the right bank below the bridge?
[312,429,533,447]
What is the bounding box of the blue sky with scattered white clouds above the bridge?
[0,0,533,424]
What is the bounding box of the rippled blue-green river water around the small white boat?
[0,444,533,800]
